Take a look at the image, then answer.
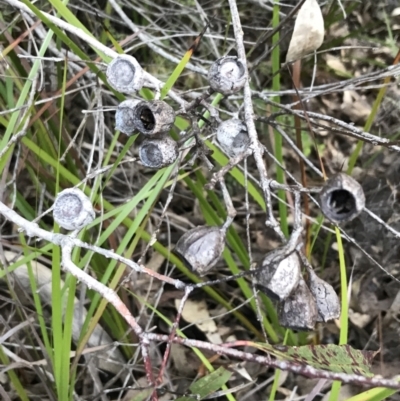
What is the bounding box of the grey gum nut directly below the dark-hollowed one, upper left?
[139,134,179,168]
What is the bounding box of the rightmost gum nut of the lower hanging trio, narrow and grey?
[307,269,340,322]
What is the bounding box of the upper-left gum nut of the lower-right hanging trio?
[255,249,301,301]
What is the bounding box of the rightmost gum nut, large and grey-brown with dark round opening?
[319,173,365,224]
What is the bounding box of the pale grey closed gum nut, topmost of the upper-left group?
[107,54,144,94]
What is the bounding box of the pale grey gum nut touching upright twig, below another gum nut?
[217,118,250,157]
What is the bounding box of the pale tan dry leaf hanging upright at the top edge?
[286,0,325,63]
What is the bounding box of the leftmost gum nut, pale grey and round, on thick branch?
[53,188,95,230]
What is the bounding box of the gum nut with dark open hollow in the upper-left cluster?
[134,100,175,136]
